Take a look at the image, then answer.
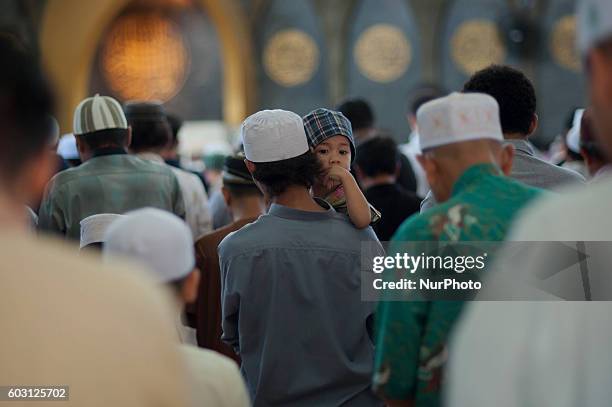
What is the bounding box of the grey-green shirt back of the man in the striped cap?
[38,154,185,239]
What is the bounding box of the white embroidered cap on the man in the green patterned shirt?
[417,93,504,151]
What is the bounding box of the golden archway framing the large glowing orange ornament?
[40,0,254,129]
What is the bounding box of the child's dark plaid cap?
[303,108,355,162]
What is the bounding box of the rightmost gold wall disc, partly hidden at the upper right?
[550,15,581,72]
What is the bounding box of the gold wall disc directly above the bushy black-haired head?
[451,19,506,76]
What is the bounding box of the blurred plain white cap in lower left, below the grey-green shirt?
[102,208,195,283]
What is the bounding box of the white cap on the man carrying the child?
[240,110,309,163]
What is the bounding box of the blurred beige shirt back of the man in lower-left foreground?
[0,232,189,407]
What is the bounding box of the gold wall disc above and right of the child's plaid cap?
[353,24,412,83]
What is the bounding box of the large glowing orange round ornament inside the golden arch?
[101,12,190,102]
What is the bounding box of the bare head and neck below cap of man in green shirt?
[418,139,514,202]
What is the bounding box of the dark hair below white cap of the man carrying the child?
[253,151,324,196]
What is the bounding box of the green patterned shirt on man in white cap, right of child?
[374,164,540,406]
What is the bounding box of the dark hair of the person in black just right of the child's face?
[355,135,399,177]
